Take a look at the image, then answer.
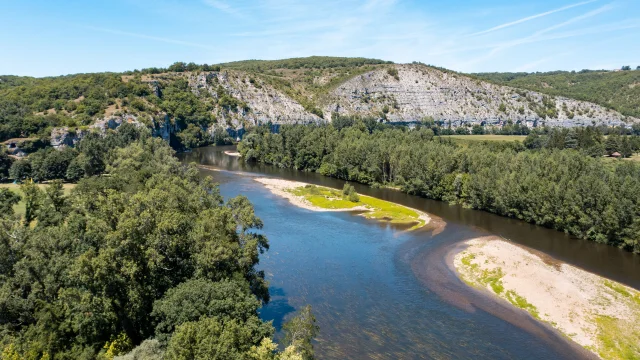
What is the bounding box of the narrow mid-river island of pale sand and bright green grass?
[254,178,431,230]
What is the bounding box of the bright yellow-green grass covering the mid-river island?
[290,185,425,228]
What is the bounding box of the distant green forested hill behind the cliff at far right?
[473,70,640,117]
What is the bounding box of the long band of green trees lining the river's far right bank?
[239,121,640,252]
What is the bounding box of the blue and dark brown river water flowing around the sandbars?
[179,147,640,359]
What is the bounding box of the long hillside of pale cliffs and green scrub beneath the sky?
[0,57,640,145]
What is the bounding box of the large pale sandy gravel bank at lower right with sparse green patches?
[453,237,640,359]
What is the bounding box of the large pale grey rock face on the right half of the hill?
[324,64,638,126]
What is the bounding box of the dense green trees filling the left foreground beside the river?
[0,127,318,360]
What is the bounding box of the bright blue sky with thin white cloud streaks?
[0,0,640,76]
